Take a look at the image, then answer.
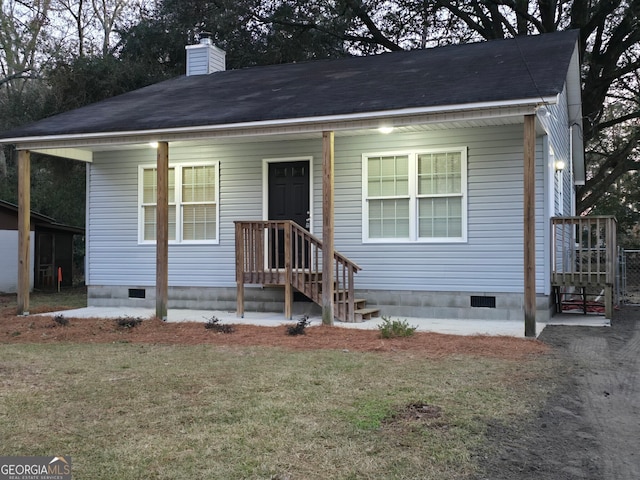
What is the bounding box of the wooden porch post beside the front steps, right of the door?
[322,132,334,325]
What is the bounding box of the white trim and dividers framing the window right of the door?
[362,146,469,244]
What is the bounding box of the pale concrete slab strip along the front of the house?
[43,307,611,337]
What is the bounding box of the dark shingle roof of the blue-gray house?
[0,31,577,139]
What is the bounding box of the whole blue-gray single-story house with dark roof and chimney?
[0,31,608,334]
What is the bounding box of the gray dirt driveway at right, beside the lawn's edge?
[476,307,640,480]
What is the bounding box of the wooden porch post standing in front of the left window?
[156,142,169,321]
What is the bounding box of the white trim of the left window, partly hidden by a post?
[138,160,220,245]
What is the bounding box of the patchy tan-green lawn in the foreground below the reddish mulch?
[0,344,553,480]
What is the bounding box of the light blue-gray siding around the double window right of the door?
[335,125,544,292]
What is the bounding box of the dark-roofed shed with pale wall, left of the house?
[0,200,84,293]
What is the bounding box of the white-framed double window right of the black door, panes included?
[362,147,467,242]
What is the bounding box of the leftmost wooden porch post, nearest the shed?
[17,150,31,315]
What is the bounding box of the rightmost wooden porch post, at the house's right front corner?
[524,115,536,337]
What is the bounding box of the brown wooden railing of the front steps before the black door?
[235,220,360,322]
